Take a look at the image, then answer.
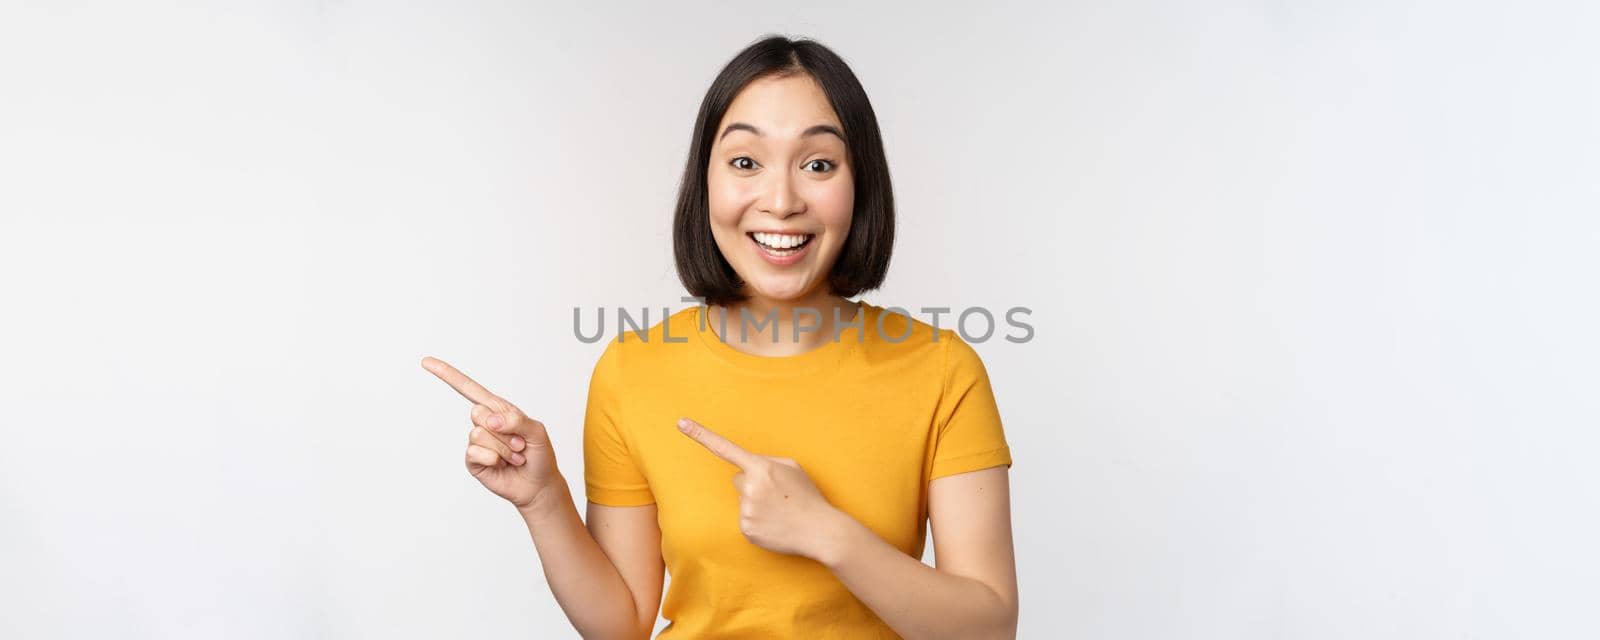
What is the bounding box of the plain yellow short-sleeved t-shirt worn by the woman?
[584,301,1011,638]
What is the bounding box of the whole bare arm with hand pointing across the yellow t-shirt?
[678,418,1018,638]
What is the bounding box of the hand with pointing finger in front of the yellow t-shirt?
[678,418,846,560]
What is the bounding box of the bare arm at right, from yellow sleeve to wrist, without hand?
[816,467,1018,638]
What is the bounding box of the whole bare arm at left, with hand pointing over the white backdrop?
[422,358,662,640]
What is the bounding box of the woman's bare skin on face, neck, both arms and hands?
[422,74,1018,638]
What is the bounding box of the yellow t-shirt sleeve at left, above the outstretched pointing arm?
[584,341,656,507]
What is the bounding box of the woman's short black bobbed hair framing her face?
[672,35,894,304]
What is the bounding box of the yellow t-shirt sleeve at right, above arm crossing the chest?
[930,330,1011,480]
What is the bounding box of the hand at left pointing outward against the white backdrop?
[422,357,563,510]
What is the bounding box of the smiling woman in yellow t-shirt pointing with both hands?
[422,37,1018,638]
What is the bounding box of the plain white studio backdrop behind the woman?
[0,2,1600,640]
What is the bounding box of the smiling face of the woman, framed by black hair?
[706,74,856,302]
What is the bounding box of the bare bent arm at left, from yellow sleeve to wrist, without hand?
[517,482,662,638]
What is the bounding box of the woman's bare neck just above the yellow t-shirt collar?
[707,291,859,355]
